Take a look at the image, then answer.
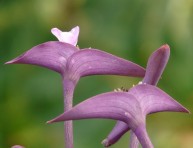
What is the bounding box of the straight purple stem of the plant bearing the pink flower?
[63,79,76,148]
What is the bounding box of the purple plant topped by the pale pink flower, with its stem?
[6,26,145,148]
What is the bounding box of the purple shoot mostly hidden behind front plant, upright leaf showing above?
[102,45,173,148]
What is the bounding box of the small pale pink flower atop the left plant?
[51,26,79,46]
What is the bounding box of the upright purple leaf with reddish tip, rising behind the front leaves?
[143,45,170,85]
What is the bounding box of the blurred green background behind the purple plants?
[0,0,193,148]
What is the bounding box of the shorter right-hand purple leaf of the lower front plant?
[129,84,189,114]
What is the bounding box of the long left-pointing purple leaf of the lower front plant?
[48,92,142,124]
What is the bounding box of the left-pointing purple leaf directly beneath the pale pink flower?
[6,41,78,74]
